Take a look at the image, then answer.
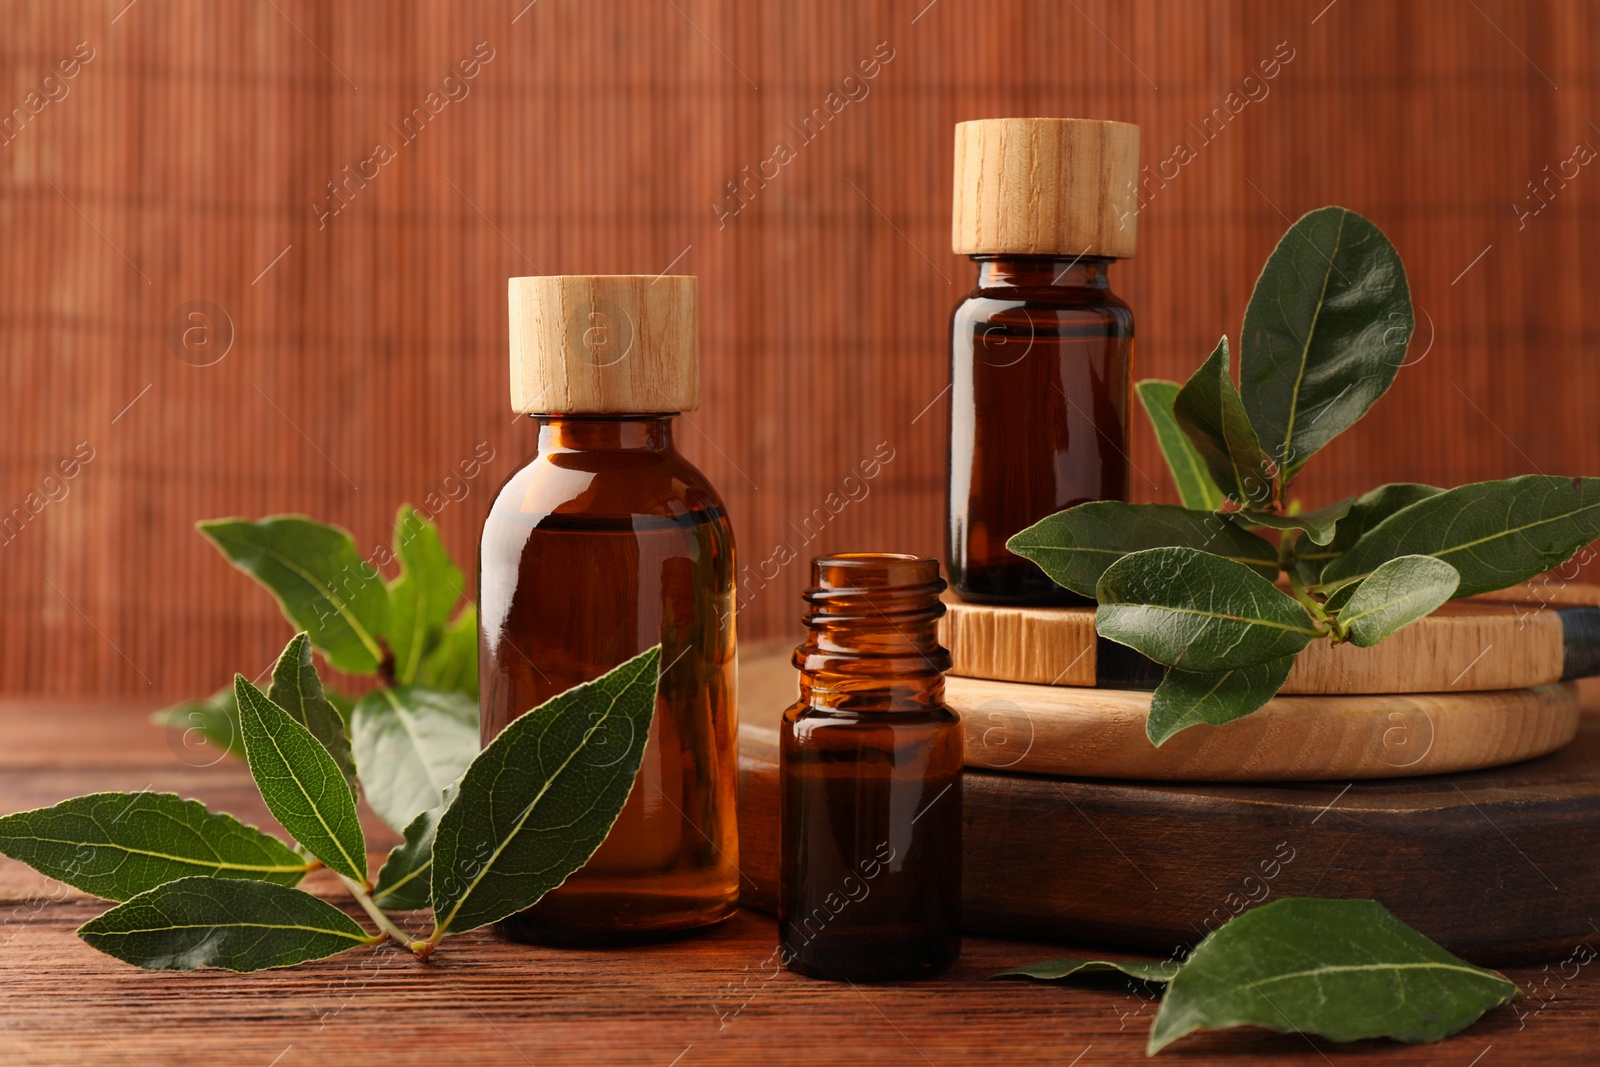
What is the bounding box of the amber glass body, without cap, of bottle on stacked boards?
[946,256,1133,605]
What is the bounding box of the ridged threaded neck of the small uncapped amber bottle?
[794,552,950,713]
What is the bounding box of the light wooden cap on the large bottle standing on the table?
[506,274,699,414]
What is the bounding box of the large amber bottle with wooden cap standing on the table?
[478,277,739,944]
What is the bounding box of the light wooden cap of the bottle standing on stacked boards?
[950,118,1139,259]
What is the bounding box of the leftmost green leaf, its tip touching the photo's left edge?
[0,792,307,901]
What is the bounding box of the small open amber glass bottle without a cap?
[778,552,962,982]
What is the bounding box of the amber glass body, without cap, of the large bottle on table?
[478,416,739,944]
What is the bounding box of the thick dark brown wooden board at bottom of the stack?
[739,657,1600,966]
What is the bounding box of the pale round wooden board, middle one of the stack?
[739,651,1579,782]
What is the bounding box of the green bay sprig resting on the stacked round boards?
[1006,208,1600,745]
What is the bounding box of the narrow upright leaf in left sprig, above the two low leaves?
[234,675,366,886]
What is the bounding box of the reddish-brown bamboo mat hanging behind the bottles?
[0,0,1600,697]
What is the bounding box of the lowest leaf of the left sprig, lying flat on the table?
[78,878,376,971]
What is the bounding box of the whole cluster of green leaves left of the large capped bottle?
[0,507,661,971]
